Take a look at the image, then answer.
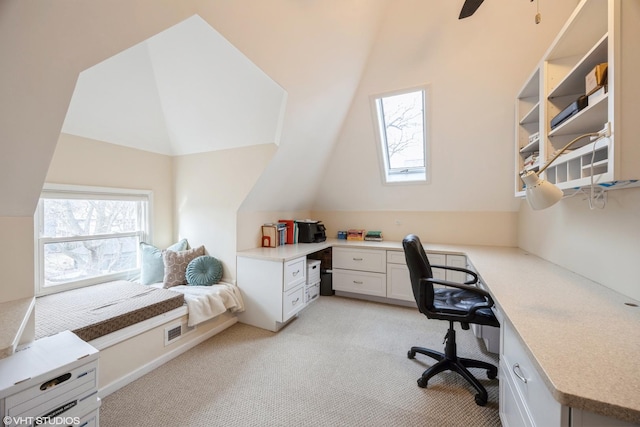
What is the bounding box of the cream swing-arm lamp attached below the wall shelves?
[520,123,611,210]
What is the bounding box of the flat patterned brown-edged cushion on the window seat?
[35,280,185,341]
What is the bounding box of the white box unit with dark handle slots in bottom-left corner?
[0,331,100,426]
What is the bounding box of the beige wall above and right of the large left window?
[46,134,176,248]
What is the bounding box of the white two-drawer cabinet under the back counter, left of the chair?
[332,247,387,297]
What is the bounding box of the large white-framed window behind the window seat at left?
[34,185,152,295]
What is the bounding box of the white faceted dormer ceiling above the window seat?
[62,15,287,155]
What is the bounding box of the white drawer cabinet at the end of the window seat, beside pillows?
[237,256,307,332]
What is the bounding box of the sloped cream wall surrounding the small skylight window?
[313,0,575,245]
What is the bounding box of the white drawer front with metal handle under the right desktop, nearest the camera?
[500,321,563,426]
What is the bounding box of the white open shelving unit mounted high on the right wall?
[515,0,640,196]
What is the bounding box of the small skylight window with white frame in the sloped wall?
[372,87,428,183]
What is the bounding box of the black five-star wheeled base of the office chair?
[407,330,498,406]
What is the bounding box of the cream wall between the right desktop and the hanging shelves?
[518,188,640,300]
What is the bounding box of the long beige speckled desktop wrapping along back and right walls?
[238,239,640,422]
